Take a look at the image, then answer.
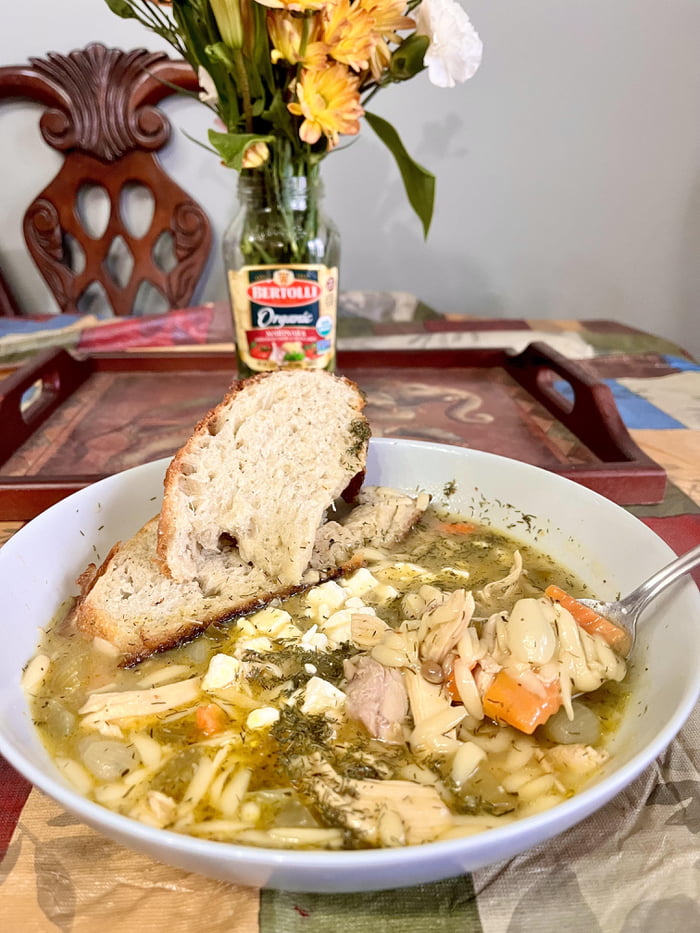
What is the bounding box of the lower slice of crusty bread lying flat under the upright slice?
[69,486,428,666]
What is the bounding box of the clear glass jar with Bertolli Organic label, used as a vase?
[223,165,340,377]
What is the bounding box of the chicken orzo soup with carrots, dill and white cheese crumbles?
[24,507,626,849]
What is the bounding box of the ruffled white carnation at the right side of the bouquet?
[416,0,483,87]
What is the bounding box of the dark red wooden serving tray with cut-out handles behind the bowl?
[0,343,666,521]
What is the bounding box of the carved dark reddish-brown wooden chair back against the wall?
[0,44,211,316]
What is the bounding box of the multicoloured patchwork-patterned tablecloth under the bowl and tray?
[0,293,700,933]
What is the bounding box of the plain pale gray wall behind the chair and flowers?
[0,0,700,355]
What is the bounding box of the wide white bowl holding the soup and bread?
[0,439,700,892]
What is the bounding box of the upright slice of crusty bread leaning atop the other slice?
[157,370,370,586]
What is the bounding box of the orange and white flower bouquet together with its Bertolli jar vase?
[106,0,481,371]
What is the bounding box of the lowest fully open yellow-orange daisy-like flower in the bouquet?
[287,62,364,149]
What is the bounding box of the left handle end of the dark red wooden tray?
[0,350,91,464]
